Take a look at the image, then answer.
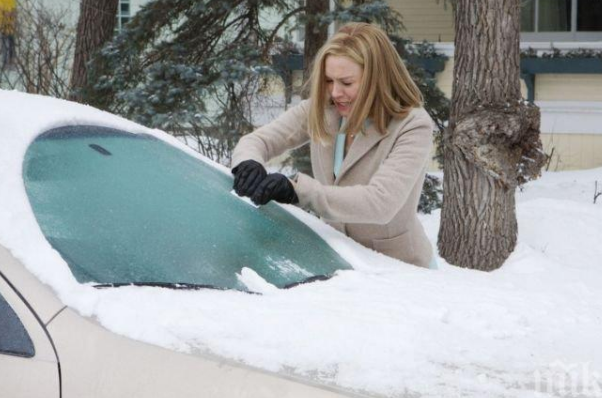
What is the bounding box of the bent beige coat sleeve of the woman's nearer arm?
[295,111,433,225]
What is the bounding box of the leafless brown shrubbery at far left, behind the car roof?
[0,0,75,98]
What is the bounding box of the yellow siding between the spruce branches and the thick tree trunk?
[388,0,454,42]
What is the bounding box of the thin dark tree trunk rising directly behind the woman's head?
[301,0,330,98]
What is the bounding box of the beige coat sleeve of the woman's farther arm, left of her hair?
[232,100,309,167]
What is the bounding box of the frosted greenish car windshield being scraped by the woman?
[24,126,351,290]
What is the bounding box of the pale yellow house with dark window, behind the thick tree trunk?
[389,0,602,170]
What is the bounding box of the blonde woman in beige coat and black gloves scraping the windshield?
[232,23,434,268]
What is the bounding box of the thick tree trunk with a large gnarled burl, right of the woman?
[438,0,545,271]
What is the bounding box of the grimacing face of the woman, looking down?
[325,55,364,117]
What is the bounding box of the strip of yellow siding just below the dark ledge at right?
[535,74,602,101]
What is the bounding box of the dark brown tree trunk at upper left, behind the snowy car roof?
[70,0,119,101]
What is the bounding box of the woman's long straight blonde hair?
[308,22,423,141]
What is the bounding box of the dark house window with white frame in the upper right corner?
[521,0,602,41]
